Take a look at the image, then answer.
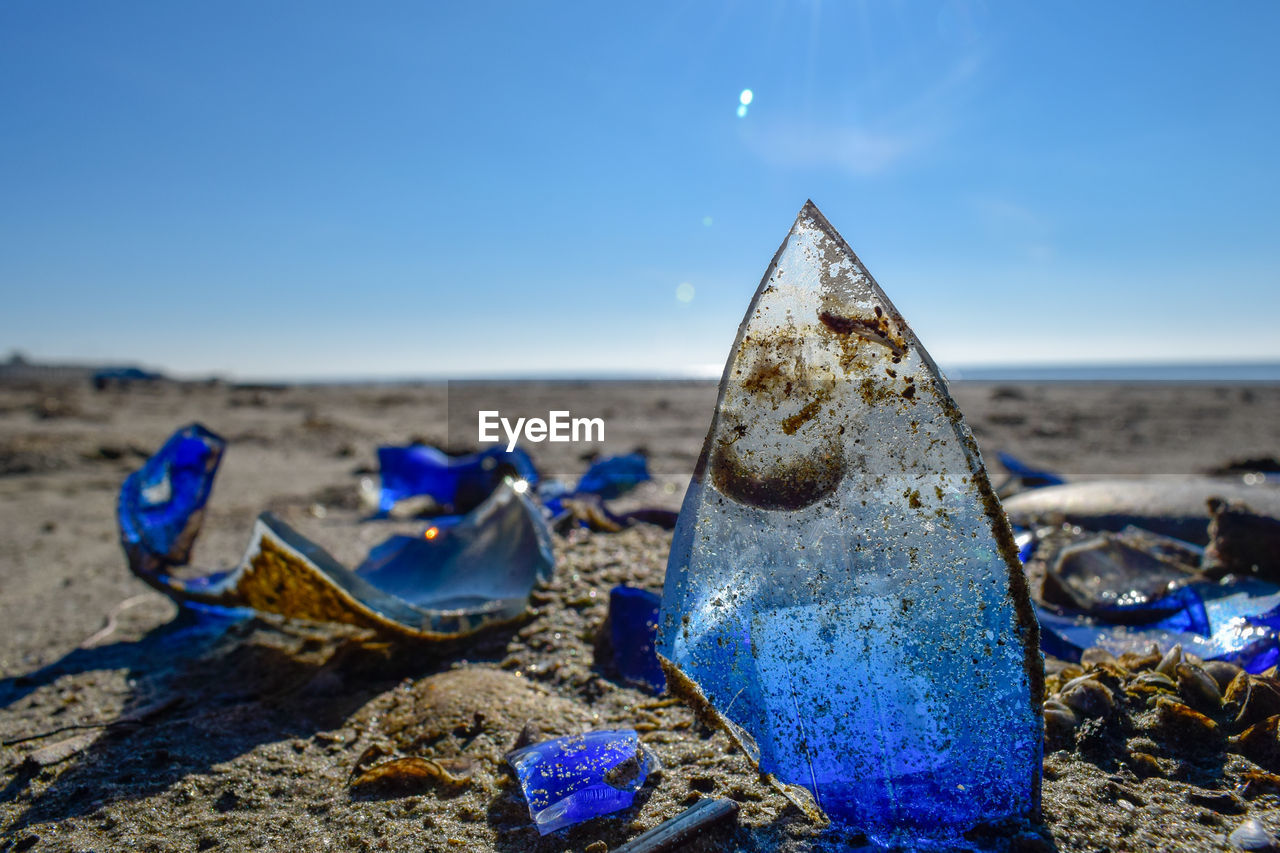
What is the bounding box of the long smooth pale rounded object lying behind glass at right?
[1005,476,1280,546]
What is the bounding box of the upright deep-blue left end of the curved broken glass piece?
[116,424,227,578]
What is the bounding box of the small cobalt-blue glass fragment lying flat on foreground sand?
[507,729,657,835]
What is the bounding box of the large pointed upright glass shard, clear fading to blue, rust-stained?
[658,204,1043,845]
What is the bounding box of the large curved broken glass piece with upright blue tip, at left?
[120,427,554,640]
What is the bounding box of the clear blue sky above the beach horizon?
[0,0,1280,378]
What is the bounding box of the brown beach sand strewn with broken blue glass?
[0,382,1280,853]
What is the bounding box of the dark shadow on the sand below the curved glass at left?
[0,610,519,834]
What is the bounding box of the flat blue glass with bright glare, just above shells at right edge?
[1037,579,1280,672]
